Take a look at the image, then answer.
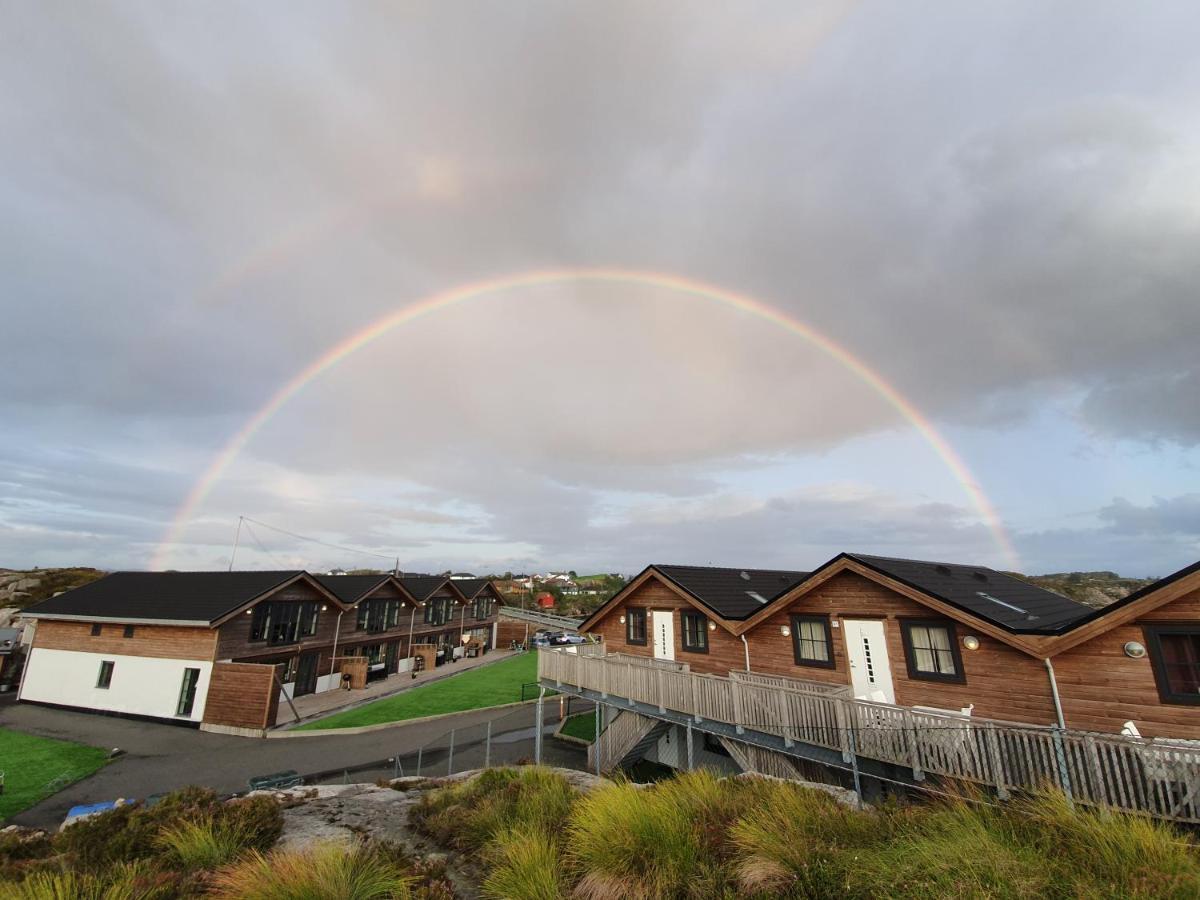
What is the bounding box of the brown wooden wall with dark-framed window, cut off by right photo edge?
[1052,590,1200,740]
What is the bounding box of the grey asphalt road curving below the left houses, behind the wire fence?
[0,697,586,828]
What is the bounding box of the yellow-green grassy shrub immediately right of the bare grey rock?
[410,766,576,850]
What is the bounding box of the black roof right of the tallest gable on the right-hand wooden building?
[849,553,1092,634]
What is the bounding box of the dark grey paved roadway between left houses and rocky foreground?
[0,698,580,827]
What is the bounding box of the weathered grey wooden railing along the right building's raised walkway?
[538,650,1200,822]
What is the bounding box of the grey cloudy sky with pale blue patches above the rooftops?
[0,0,1200,576]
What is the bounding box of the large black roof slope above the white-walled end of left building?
[28,570,304,623]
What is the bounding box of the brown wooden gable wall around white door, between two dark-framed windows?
[746,572,1055,725]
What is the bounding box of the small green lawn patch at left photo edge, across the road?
[0,728,108,821]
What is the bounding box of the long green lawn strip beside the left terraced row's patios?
[298,653,538,731]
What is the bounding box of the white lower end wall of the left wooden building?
[20,647,212,722]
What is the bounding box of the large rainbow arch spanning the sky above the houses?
[151,269,1020,570]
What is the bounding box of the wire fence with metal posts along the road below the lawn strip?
[305,695,594,785]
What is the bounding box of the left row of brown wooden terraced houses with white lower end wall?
[20,571,498,731]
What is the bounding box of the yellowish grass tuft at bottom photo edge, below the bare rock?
[212,844,410,900]
